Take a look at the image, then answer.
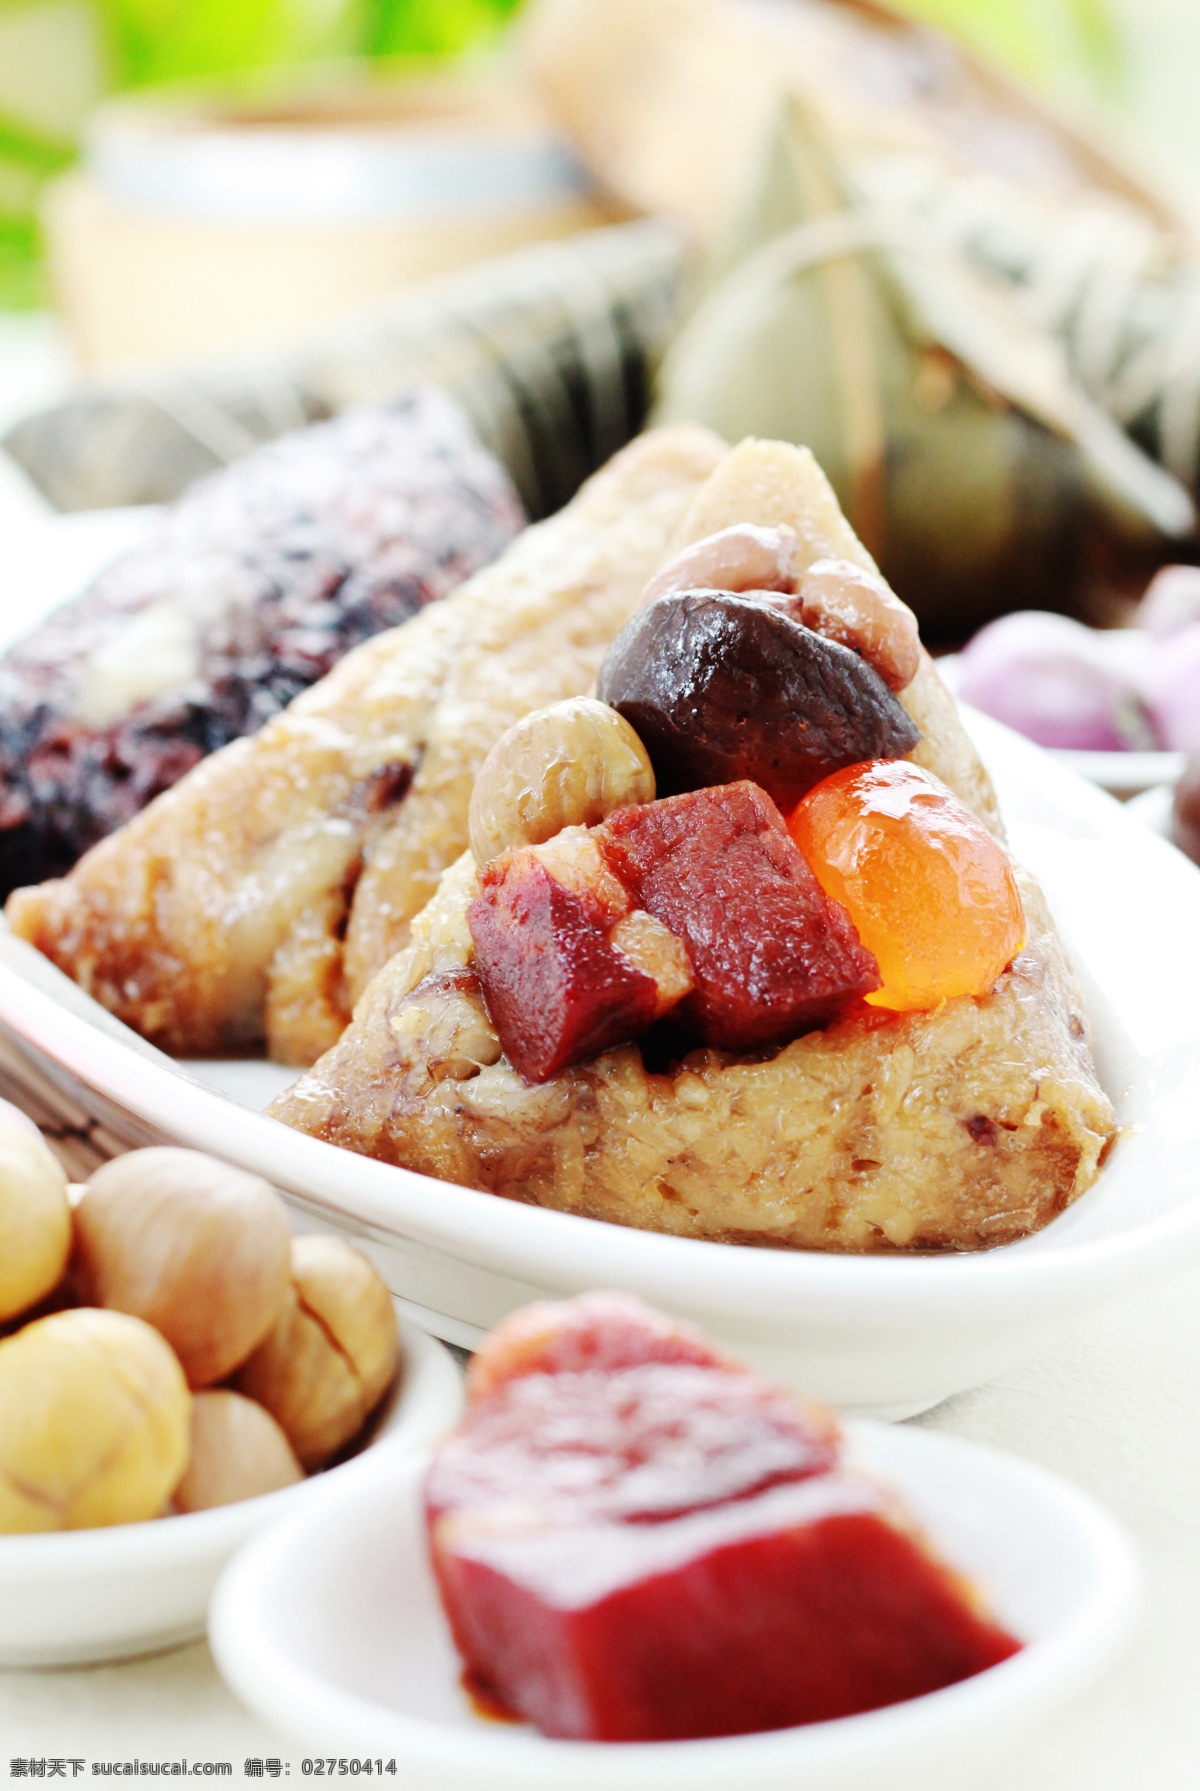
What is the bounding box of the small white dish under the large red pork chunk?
[210,1420,1137,1791]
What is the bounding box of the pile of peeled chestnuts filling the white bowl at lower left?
[0,1139,399,1533]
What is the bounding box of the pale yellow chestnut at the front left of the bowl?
[0,1307,192,1535]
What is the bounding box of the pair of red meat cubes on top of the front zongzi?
[467,783,879,1082]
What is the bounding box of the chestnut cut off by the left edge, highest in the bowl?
[0,1103,72,1320]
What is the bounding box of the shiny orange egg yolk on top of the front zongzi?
[788,759,1024,1012]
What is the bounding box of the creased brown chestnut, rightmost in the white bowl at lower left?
[236,1236,399,1469]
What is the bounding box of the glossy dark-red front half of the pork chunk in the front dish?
[435,1474,1017,1741]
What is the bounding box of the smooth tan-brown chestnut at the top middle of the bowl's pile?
[75,1148,292,1386]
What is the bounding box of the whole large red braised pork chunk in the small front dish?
[426,1293,1019,1741]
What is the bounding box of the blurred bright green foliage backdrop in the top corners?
[0,0,1200,342]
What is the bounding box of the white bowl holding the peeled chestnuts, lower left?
[0,1320,462,1667]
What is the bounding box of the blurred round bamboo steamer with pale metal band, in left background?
[45,77,623,376]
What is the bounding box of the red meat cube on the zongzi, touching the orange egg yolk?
[595,781,879,1051]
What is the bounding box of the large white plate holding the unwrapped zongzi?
[0,711,1200,1417]
